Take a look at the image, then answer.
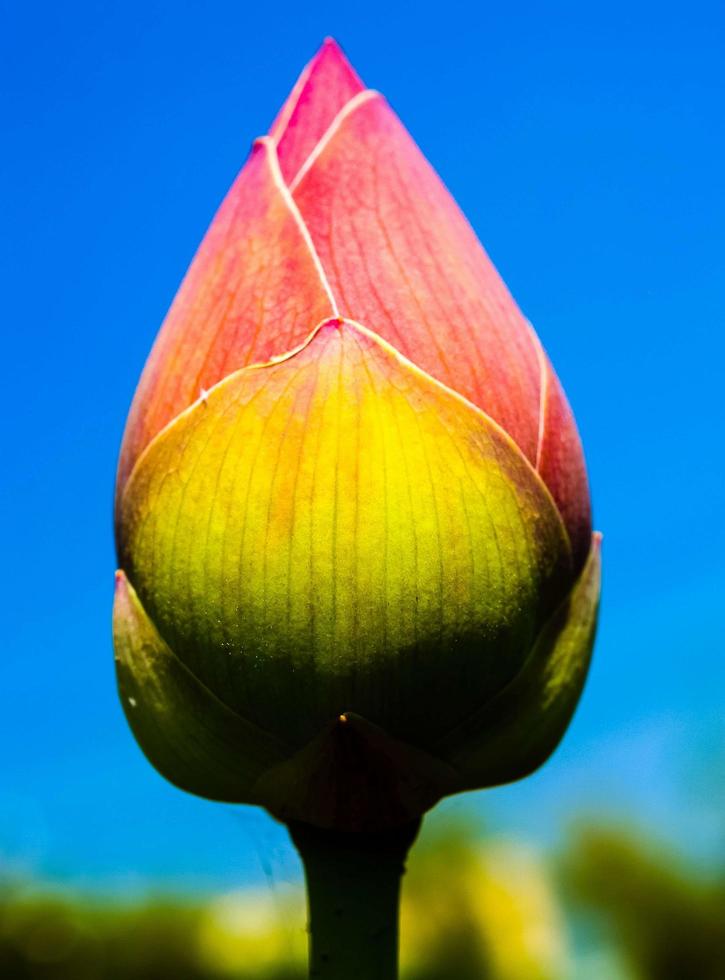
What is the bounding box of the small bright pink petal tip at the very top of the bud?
[269,38,365,181]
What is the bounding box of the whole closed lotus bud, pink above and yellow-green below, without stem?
[114,41,599,830]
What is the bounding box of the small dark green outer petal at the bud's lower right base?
[438,534,601,791]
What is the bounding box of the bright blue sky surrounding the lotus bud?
[0,0,725,888]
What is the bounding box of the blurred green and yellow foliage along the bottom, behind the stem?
[0,818,725,980]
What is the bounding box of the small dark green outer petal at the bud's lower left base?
[113,572,289,803]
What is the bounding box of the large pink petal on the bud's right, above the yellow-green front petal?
[291,93,591,560]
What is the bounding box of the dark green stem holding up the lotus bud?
[289,820,420,980]
